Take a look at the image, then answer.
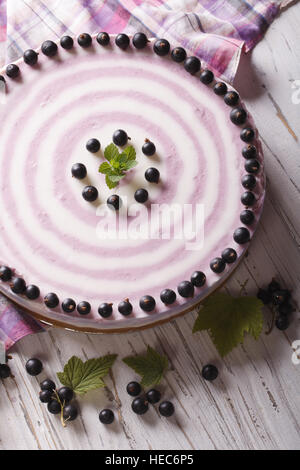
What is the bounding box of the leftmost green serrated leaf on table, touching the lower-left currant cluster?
[57,354,117,395]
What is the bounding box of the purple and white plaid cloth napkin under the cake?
[0,0,291,349]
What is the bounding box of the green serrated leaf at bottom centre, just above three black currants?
[123,346,168,387]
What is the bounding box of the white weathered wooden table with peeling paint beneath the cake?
[0,3,300,450]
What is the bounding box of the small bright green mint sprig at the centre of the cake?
[99,143,138,189]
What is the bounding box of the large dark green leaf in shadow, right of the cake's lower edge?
[193,292,263,357]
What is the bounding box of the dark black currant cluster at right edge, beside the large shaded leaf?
[257,279,294,330]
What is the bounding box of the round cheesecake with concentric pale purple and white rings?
[0,36,265,331]
